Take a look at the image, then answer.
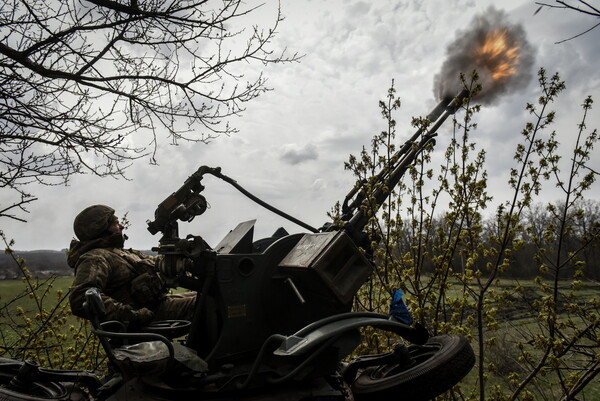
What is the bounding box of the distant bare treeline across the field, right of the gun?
[396,200,600,280]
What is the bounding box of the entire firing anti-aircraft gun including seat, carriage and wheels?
[0,92,475,401]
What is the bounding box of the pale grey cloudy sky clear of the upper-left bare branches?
[0,0,600,250]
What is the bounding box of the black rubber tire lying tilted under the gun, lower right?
[351,335,475,401]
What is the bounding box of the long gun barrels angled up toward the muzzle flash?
[342,89,469,241]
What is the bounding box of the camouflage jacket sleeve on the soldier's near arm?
[69,249,135,321]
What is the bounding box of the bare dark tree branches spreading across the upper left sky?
[0,0,299,218]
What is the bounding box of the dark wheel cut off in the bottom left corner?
[0,358,88,401]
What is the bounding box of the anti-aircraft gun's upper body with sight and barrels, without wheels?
[148,90,468,386]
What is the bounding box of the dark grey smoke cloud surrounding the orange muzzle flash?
[433,7,535,104]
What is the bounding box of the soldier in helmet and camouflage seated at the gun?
[68,205,196,326]
